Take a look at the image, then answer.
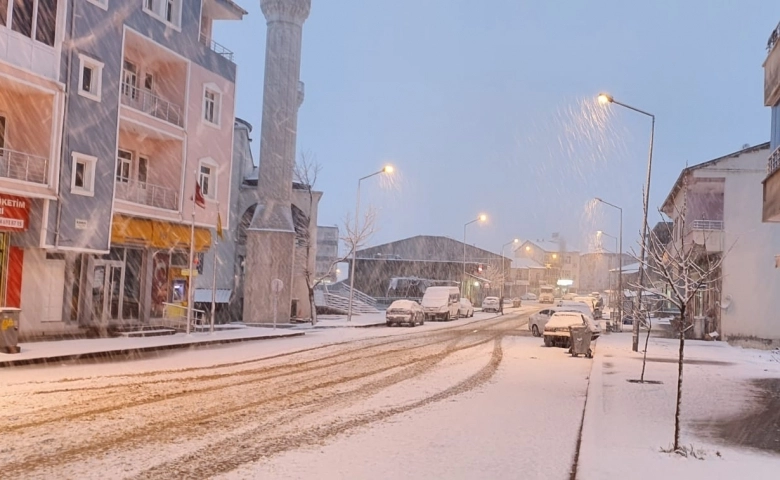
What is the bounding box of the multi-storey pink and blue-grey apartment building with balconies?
[0,0,246,334]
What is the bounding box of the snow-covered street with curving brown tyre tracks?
[0,310,591,479]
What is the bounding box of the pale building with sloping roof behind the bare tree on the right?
[662,143,780,344]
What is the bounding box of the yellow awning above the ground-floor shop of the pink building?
[111,215,211,252]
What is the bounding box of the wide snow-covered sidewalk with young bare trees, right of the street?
[577,333,780,480]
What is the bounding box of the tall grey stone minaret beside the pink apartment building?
[244,0,311,323]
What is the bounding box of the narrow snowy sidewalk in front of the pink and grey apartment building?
[0,328,305,368]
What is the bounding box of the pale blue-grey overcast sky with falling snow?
[214,0,780,255]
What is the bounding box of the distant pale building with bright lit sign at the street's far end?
[514,239,580,294]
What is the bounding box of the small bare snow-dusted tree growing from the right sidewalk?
[634,190,727,452]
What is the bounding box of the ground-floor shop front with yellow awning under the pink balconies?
[79,215,211,325]
